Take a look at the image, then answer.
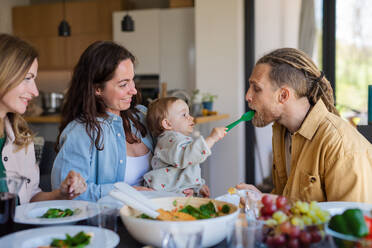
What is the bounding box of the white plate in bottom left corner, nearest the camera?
[0,226,120,248]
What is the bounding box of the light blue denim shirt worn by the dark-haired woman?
[52,105,153,201]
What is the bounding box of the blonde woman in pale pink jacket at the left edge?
[0,34,86,204]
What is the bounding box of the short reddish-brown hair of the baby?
[146,97,180,137]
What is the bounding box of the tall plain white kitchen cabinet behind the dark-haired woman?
[113,8,195,92]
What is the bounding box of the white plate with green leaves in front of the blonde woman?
[14,200,98,225]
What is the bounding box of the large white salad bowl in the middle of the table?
[120,197,239,247]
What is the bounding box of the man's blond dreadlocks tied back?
[256,48,339,116]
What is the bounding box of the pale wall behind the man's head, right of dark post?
[255,0,300,184]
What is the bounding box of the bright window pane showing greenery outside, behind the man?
[336,0,372,117]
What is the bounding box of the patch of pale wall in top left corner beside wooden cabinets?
[0,0,30,34]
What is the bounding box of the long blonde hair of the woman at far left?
[0,34,38,149]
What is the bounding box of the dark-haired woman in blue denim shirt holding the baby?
[52,41,153,201]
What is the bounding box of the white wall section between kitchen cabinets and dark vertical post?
[195,0,245,196]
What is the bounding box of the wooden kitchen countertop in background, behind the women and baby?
[25,114,229,124]
